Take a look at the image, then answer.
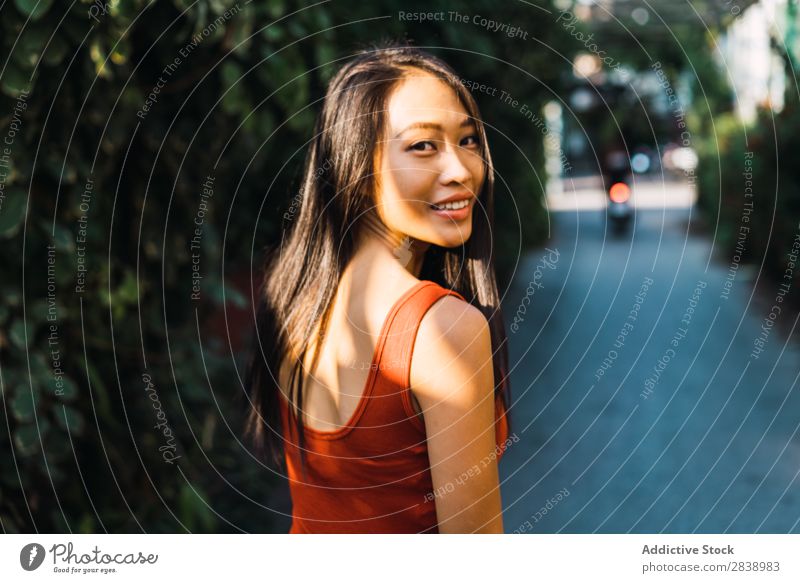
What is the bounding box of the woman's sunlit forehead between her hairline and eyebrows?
[387,70,468,129]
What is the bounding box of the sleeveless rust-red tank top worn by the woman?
[280,281,508,534]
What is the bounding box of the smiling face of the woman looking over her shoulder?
[375,70,484,247]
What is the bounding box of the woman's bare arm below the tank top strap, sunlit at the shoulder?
[411,296,503,533]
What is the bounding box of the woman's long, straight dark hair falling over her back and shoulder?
[245,45,509,468]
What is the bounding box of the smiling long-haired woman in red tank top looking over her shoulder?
[247,46,508,533]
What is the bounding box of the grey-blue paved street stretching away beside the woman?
[500,204,800,533]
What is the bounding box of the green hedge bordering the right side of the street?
[698,91,800,288]
